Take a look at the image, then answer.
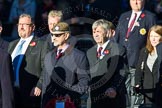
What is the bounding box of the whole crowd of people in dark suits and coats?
[0,0,162,108]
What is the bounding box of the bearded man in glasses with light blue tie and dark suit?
[8,14,48,108]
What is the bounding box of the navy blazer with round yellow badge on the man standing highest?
[115,10,156,68]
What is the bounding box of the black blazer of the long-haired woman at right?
[135,48,159,89]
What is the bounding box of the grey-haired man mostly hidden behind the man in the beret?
[41,10,77,50]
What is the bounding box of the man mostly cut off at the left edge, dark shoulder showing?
[0,21,9,51]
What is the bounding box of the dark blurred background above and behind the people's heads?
[0,0,162,41]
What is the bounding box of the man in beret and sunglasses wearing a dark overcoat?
[42,22,89,108]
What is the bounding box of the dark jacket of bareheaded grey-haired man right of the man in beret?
[87,41,127,107]
